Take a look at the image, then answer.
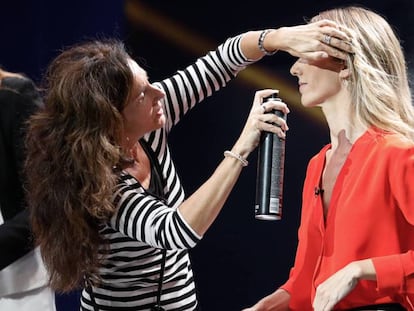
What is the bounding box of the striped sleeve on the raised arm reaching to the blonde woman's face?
[154,35,254,132]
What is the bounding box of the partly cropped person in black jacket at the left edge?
[0,68,55,311]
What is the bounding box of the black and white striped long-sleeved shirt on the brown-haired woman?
[81,36,252,311]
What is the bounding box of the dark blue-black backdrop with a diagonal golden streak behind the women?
[0,0,414,311]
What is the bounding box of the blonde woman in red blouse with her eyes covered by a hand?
[246,7,414,311]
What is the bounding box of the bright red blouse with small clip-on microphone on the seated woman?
[282,130,414,311]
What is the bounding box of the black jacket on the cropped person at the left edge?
[0,77,41,270]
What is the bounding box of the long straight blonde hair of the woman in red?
[311,6,414,141]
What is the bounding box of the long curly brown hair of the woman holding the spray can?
[25,40,133,292]
